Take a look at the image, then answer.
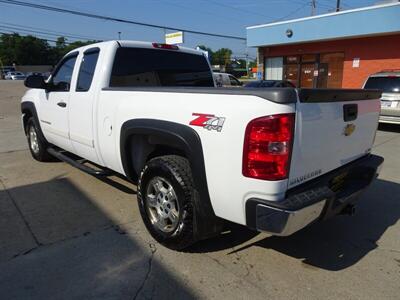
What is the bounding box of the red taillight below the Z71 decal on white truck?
[242,114,294,180]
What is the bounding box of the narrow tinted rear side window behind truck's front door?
[76,49,99,92]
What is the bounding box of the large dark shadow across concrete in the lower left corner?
[0,178,195,299]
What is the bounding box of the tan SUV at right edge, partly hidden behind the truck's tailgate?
[364,70,400,124]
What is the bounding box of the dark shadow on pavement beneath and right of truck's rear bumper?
[192,179,400,271]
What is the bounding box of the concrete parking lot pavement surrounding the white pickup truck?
[0,81,400,299]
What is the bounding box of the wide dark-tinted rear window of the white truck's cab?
[110,48,214,87]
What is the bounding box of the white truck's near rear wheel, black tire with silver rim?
[138,155,196,250]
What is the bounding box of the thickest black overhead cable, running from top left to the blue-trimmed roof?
[0,0,246,40]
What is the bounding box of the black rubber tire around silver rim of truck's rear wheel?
[137,155,197,250]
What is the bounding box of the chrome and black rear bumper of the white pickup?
[246,155,383,236]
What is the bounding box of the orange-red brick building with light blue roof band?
[247,2,400,88]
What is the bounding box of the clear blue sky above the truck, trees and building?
[0,0,378,58]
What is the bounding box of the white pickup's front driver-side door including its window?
[40,54,77,151]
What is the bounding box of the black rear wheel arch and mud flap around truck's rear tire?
[120,119,219,239]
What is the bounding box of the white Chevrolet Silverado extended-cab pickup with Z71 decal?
[22,41,383,249]
